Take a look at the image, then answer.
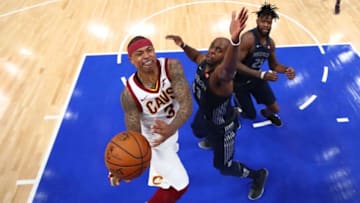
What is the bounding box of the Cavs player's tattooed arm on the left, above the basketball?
[120,87,141,132]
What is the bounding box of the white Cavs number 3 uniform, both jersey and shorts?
[126,58,189,191]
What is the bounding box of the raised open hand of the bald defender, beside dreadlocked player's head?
[230,7,248,43]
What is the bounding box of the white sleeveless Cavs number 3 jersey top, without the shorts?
[127,58,179,140]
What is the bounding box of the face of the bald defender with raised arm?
[206,38,229,66]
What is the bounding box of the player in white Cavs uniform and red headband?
[110,36,192,203]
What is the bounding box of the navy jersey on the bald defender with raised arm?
[192,61,235,126]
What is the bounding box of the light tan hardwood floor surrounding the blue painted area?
[0,0,360,202]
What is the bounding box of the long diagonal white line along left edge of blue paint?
[28,55,86,203]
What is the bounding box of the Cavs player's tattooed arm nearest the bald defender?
[168,59,192,129]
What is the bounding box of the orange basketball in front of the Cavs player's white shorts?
[104,131,151,180]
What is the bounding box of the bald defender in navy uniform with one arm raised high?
[166,8,268,200]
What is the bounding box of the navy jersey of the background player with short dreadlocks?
[235,28,271,82]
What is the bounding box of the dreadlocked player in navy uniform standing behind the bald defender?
[234,3,295,126]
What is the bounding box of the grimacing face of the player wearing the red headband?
[130,46,156,72]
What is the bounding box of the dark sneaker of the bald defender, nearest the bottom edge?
[248,168,269,200]
